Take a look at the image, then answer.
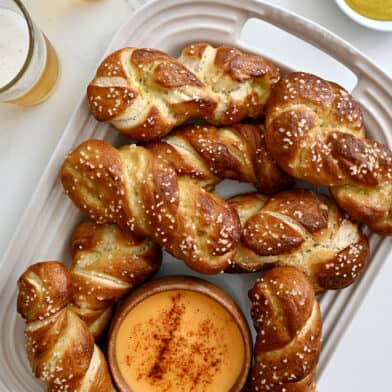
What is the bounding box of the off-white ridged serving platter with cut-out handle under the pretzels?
[0,0,392,392]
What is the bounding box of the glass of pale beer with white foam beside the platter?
[0,0,60,106]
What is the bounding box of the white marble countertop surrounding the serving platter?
[0,0,392,392]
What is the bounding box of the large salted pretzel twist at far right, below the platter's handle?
[266,73,392,235]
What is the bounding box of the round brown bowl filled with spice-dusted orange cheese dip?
[109,277,251,392]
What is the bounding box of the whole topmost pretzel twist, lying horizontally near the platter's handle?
[87,44,280,141]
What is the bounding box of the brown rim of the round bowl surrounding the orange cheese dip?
[108,276,252,392]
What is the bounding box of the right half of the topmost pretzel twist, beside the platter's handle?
[178,43,280,125]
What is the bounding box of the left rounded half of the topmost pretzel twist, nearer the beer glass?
[87,48,217,140]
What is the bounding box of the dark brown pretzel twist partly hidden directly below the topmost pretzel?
[145,124,293,193]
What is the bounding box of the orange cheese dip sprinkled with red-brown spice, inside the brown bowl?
[115,290,245,392]
